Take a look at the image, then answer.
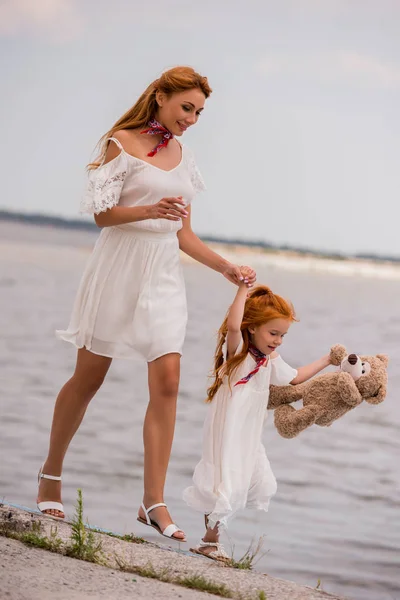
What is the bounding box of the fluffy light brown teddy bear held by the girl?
[268,344,389,438]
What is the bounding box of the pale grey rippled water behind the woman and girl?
[0,223,400,600]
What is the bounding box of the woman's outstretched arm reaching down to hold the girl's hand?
[178,206,256,287]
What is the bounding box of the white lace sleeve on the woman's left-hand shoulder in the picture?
[80,152,127,215]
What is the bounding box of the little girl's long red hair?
[207,285,297,402]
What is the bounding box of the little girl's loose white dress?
[183,343,297,529]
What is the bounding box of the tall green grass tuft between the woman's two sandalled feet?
[65,489,105,565]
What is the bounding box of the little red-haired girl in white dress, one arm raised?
[183,283,330,561]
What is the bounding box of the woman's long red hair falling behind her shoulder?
[88,67,212,170]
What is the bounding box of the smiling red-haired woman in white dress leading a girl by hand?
[37,67,255,541]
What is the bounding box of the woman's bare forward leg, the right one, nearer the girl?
[139,353,185,539]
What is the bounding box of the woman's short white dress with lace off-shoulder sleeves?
[56,138,205,362]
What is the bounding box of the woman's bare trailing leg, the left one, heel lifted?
[37,348,112,517]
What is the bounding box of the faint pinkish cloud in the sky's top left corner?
[0,0,83,43]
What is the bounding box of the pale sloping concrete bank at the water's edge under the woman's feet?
[0,505,343,600]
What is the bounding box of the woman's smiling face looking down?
[156,88,206,136]
